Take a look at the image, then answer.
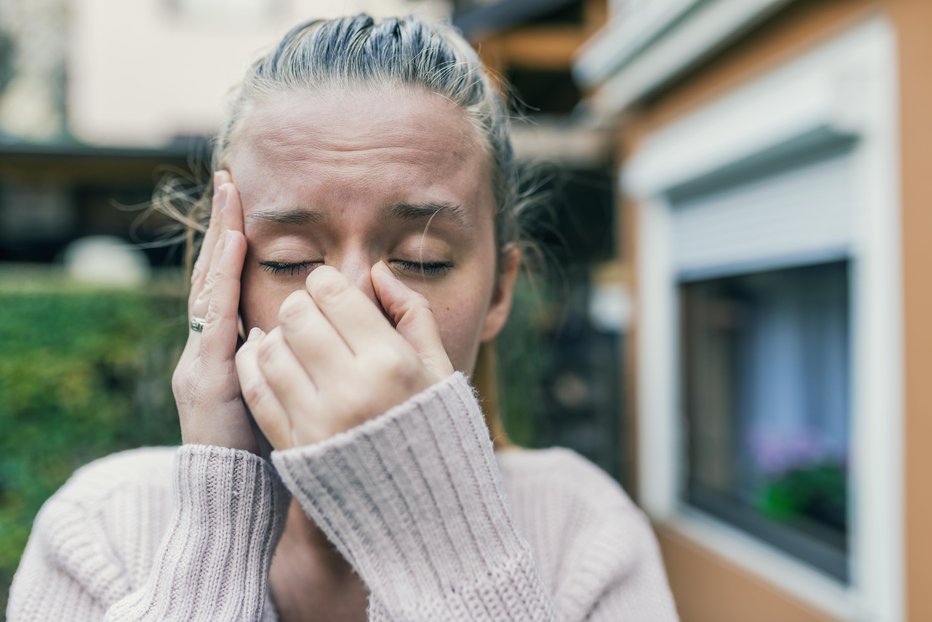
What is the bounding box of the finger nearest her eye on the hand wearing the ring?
[201,230,246,363]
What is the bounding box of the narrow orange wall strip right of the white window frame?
[889,0,932,622]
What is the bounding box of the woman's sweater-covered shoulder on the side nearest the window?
[497,448,676,620]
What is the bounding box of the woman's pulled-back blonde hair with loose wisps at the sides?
[154,15,523,447]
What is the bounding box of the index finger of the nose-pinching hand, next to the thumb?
[305,266,399,354]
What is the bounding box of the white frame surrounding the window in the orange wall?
[622,16,904,622]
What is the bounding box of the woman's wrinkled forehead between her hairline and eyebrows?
[227,88,492,222]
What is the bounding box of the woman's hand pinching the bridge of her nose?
[236,262,453,450]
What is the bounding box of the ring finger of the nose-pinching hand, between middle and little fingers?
[257,328,317,425]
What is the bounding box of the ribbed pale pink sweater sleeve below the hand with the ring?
[108,445,290,620]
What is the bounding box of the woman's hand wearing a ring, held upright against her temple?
[172,171,259,453]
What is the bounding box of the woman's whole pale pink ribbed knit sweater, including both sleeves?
[7,374,677,622]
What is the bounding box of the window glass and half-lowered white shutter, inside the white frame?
[670,146,857,583]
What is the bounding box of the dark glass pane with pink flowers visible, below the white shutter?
[680,261,850,581]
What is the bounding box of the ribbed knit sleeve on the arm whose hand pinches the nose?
[272,373,554,622]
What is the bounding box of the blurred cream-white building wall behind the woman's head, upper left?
[67,0,448,146]
